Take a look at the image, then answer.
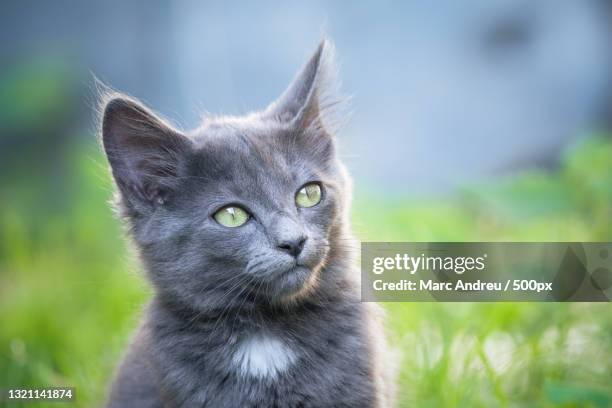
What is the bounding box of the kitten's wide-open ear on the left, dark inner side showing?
[101,95,191,212]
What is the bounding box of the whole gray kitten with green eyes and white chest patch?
[102,41,392,408]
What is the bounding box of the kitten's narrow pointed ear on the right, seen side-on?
[264,40,345,133]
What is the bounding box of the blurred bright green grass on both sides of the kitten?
[0,137,612,407]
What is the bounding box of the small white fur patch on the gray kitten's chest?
[233,335,297,379]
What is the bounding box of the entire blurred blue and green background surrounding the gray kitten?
[0,0,612,407]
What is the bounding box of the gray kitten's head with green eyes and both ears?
[101,41,349,308]
